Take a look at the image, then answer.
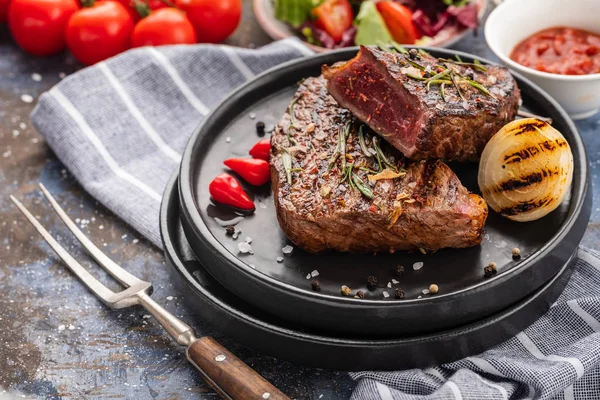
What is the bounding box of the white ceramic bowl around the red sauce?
[485,0,600,119]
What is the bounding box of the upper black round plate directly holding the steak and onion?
[179,49,591,337]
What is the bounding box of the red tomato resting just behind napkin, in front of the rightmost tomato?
[131,8,196,47]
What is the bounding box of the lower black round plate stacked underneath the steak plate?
[160,173,574,371]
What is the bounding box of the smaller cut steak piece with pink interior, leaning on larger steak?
[323,46,520,161]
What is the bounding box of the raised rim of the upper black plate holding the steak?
[178,46,589,307]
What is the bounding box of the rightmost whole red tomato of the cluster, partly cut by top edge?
[175,0,242,43]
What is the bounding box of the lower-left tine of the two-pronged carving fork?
[10,196,115,303]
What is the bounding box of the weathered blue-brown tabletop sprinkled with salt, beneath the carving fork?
[0,1,600,399]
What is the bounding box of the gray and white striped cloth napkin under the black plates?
[32,39,600,400]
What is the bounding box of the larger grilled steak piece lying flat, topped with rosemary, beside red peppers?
[271,77,487,252]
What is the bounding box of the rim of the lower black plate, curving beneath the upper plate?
[159,172,578,347]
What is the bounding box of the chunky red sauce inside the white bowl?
[510,27,600,75]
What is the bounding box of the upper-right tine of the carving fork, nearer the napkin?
[39,183,143,287]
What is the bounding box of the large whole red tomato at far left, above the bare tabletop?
[8,0,79,56]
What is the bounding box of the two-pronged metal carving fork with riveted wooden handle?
[10,184,288,400]
